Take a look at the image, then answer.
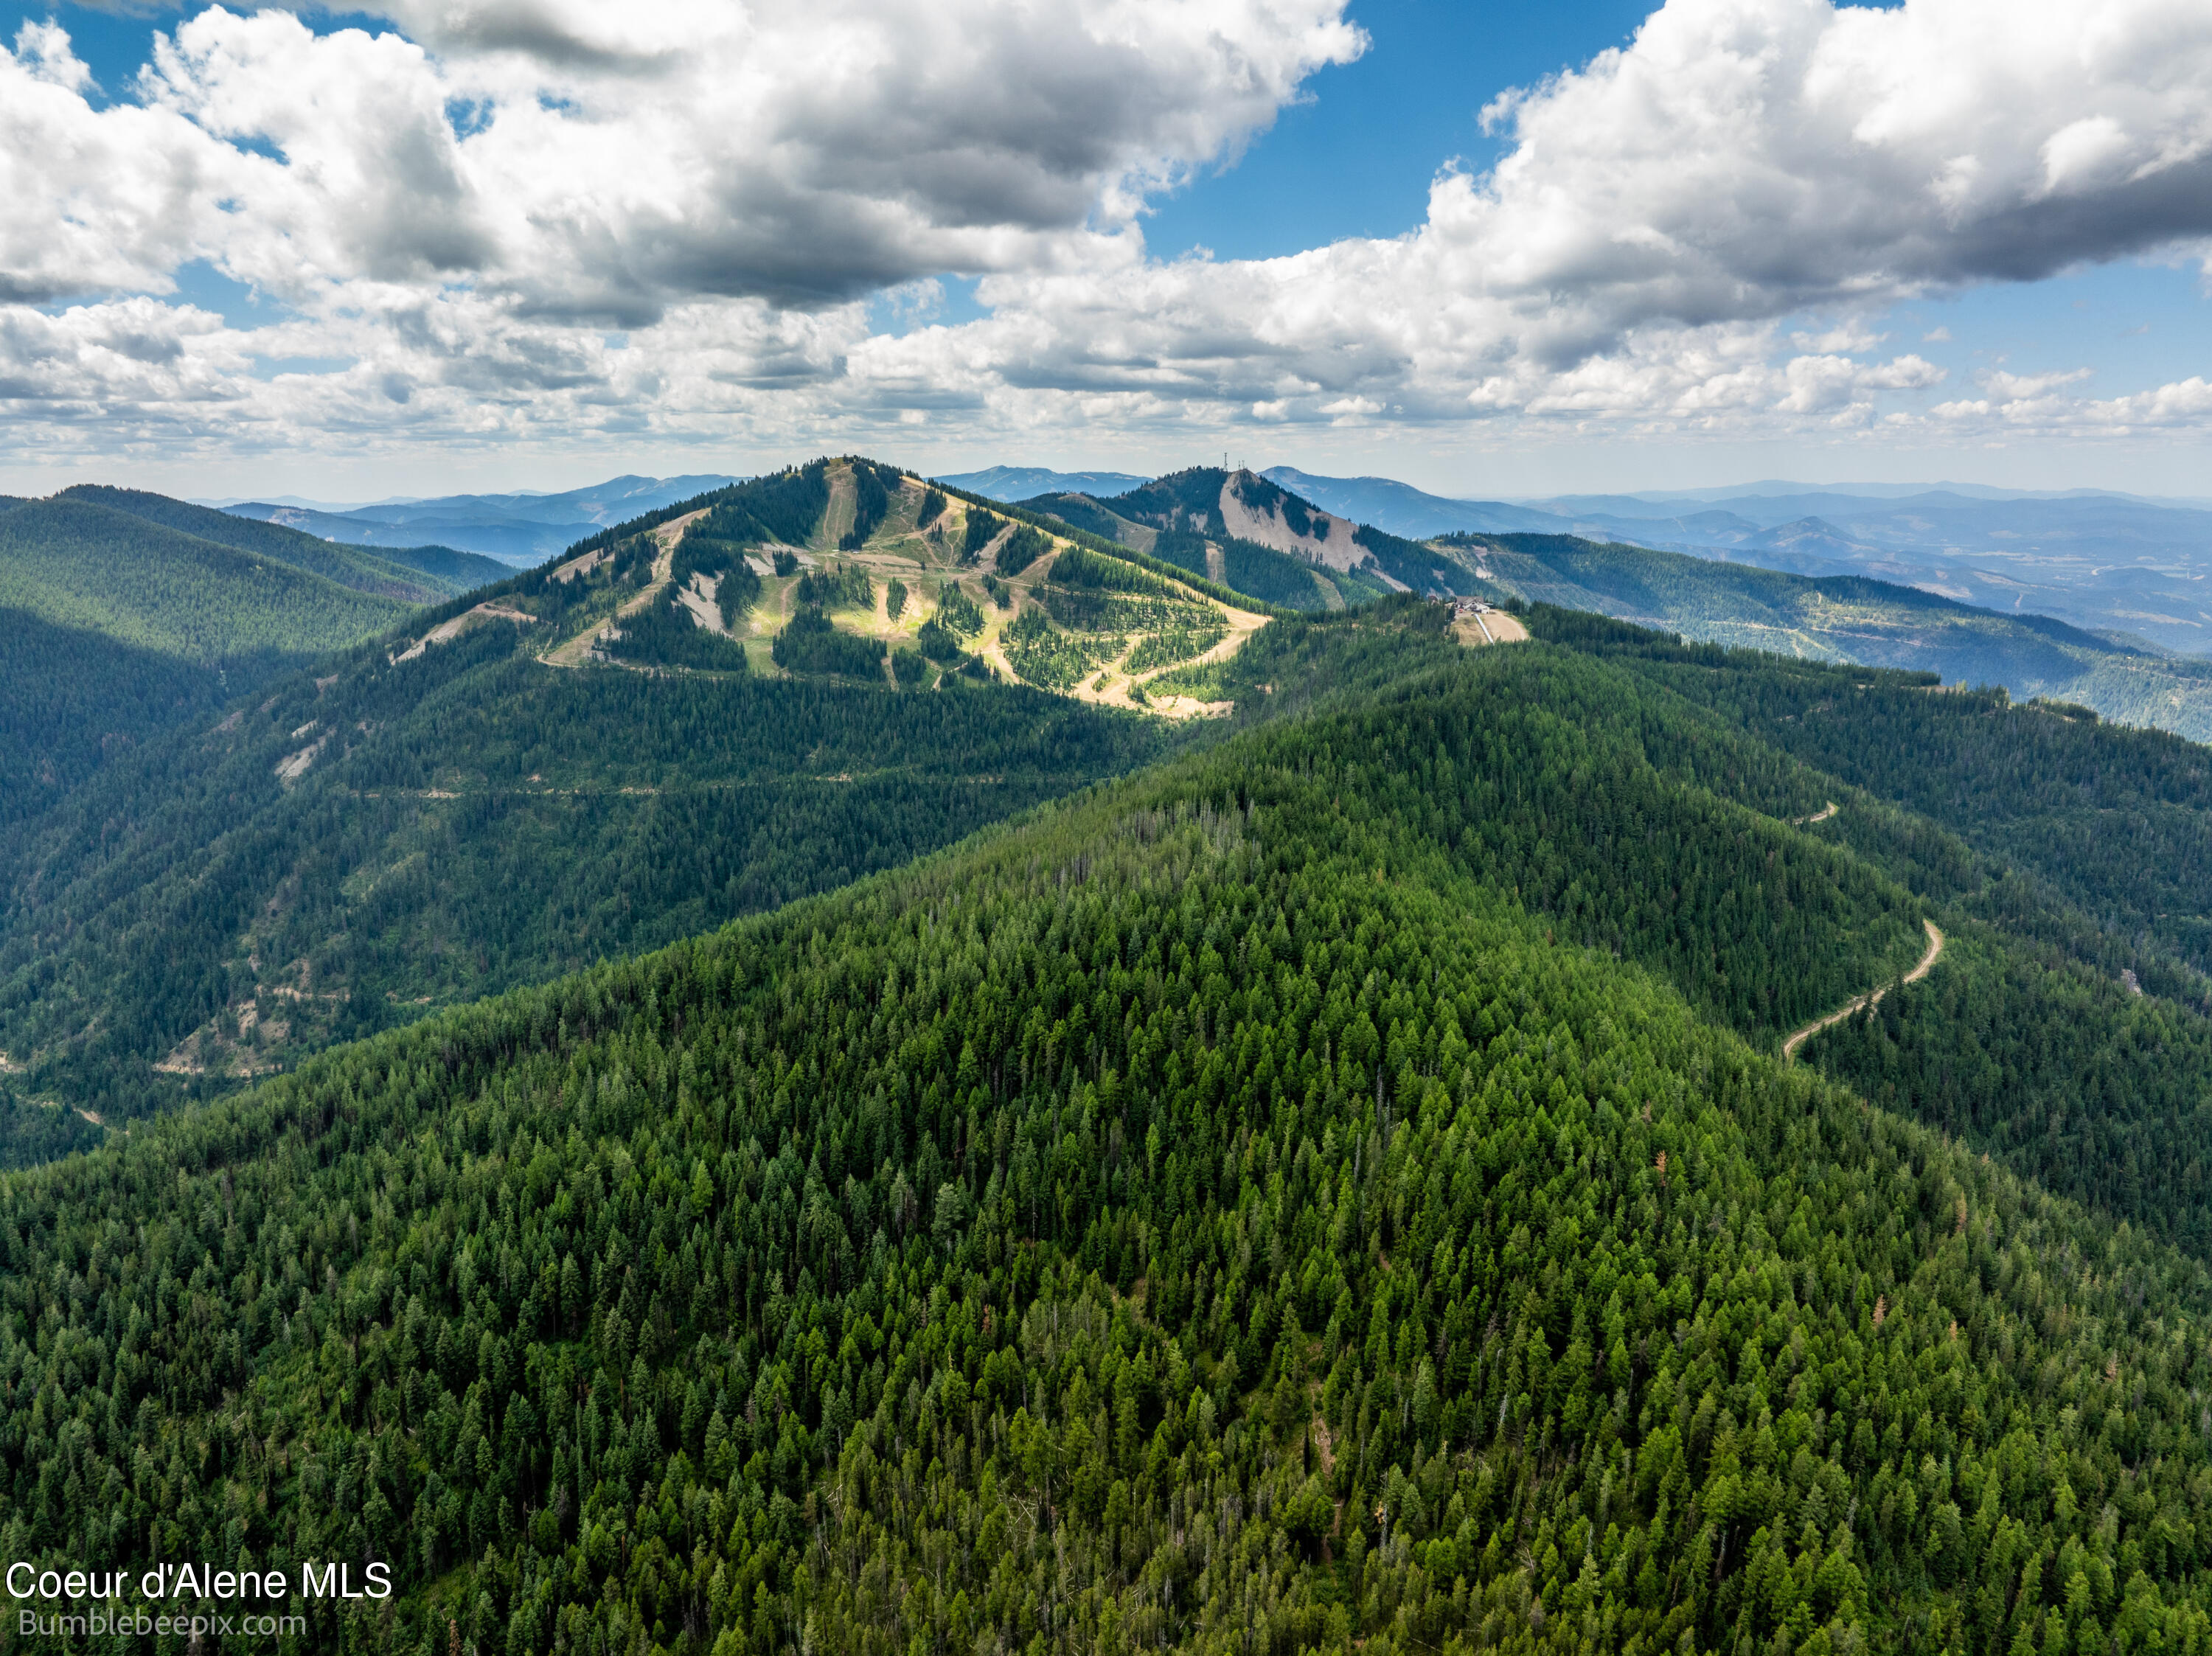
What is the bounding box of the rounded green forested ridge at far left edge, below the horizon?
[0,498,411,664]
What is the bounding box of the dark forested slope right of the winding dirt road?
[1531,610,2212,1258]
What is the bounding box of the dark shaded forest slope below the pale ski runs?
[0,622,1166,1116]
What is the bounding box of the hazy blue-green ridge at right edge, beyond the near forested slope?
[1438,535,2212,741]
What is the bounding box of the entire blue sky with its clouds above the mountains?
[0,0,2212,495]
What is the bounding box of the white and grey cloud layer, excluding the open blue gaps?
[0,0,2212,475]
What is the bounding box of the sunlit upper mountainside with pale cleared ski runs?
[542,458,1272,717]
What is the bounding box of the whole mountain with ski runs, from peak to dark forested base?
[0,462,1263,1158]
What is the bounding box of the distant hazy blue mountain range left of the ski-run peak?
[223,473,743,566]
